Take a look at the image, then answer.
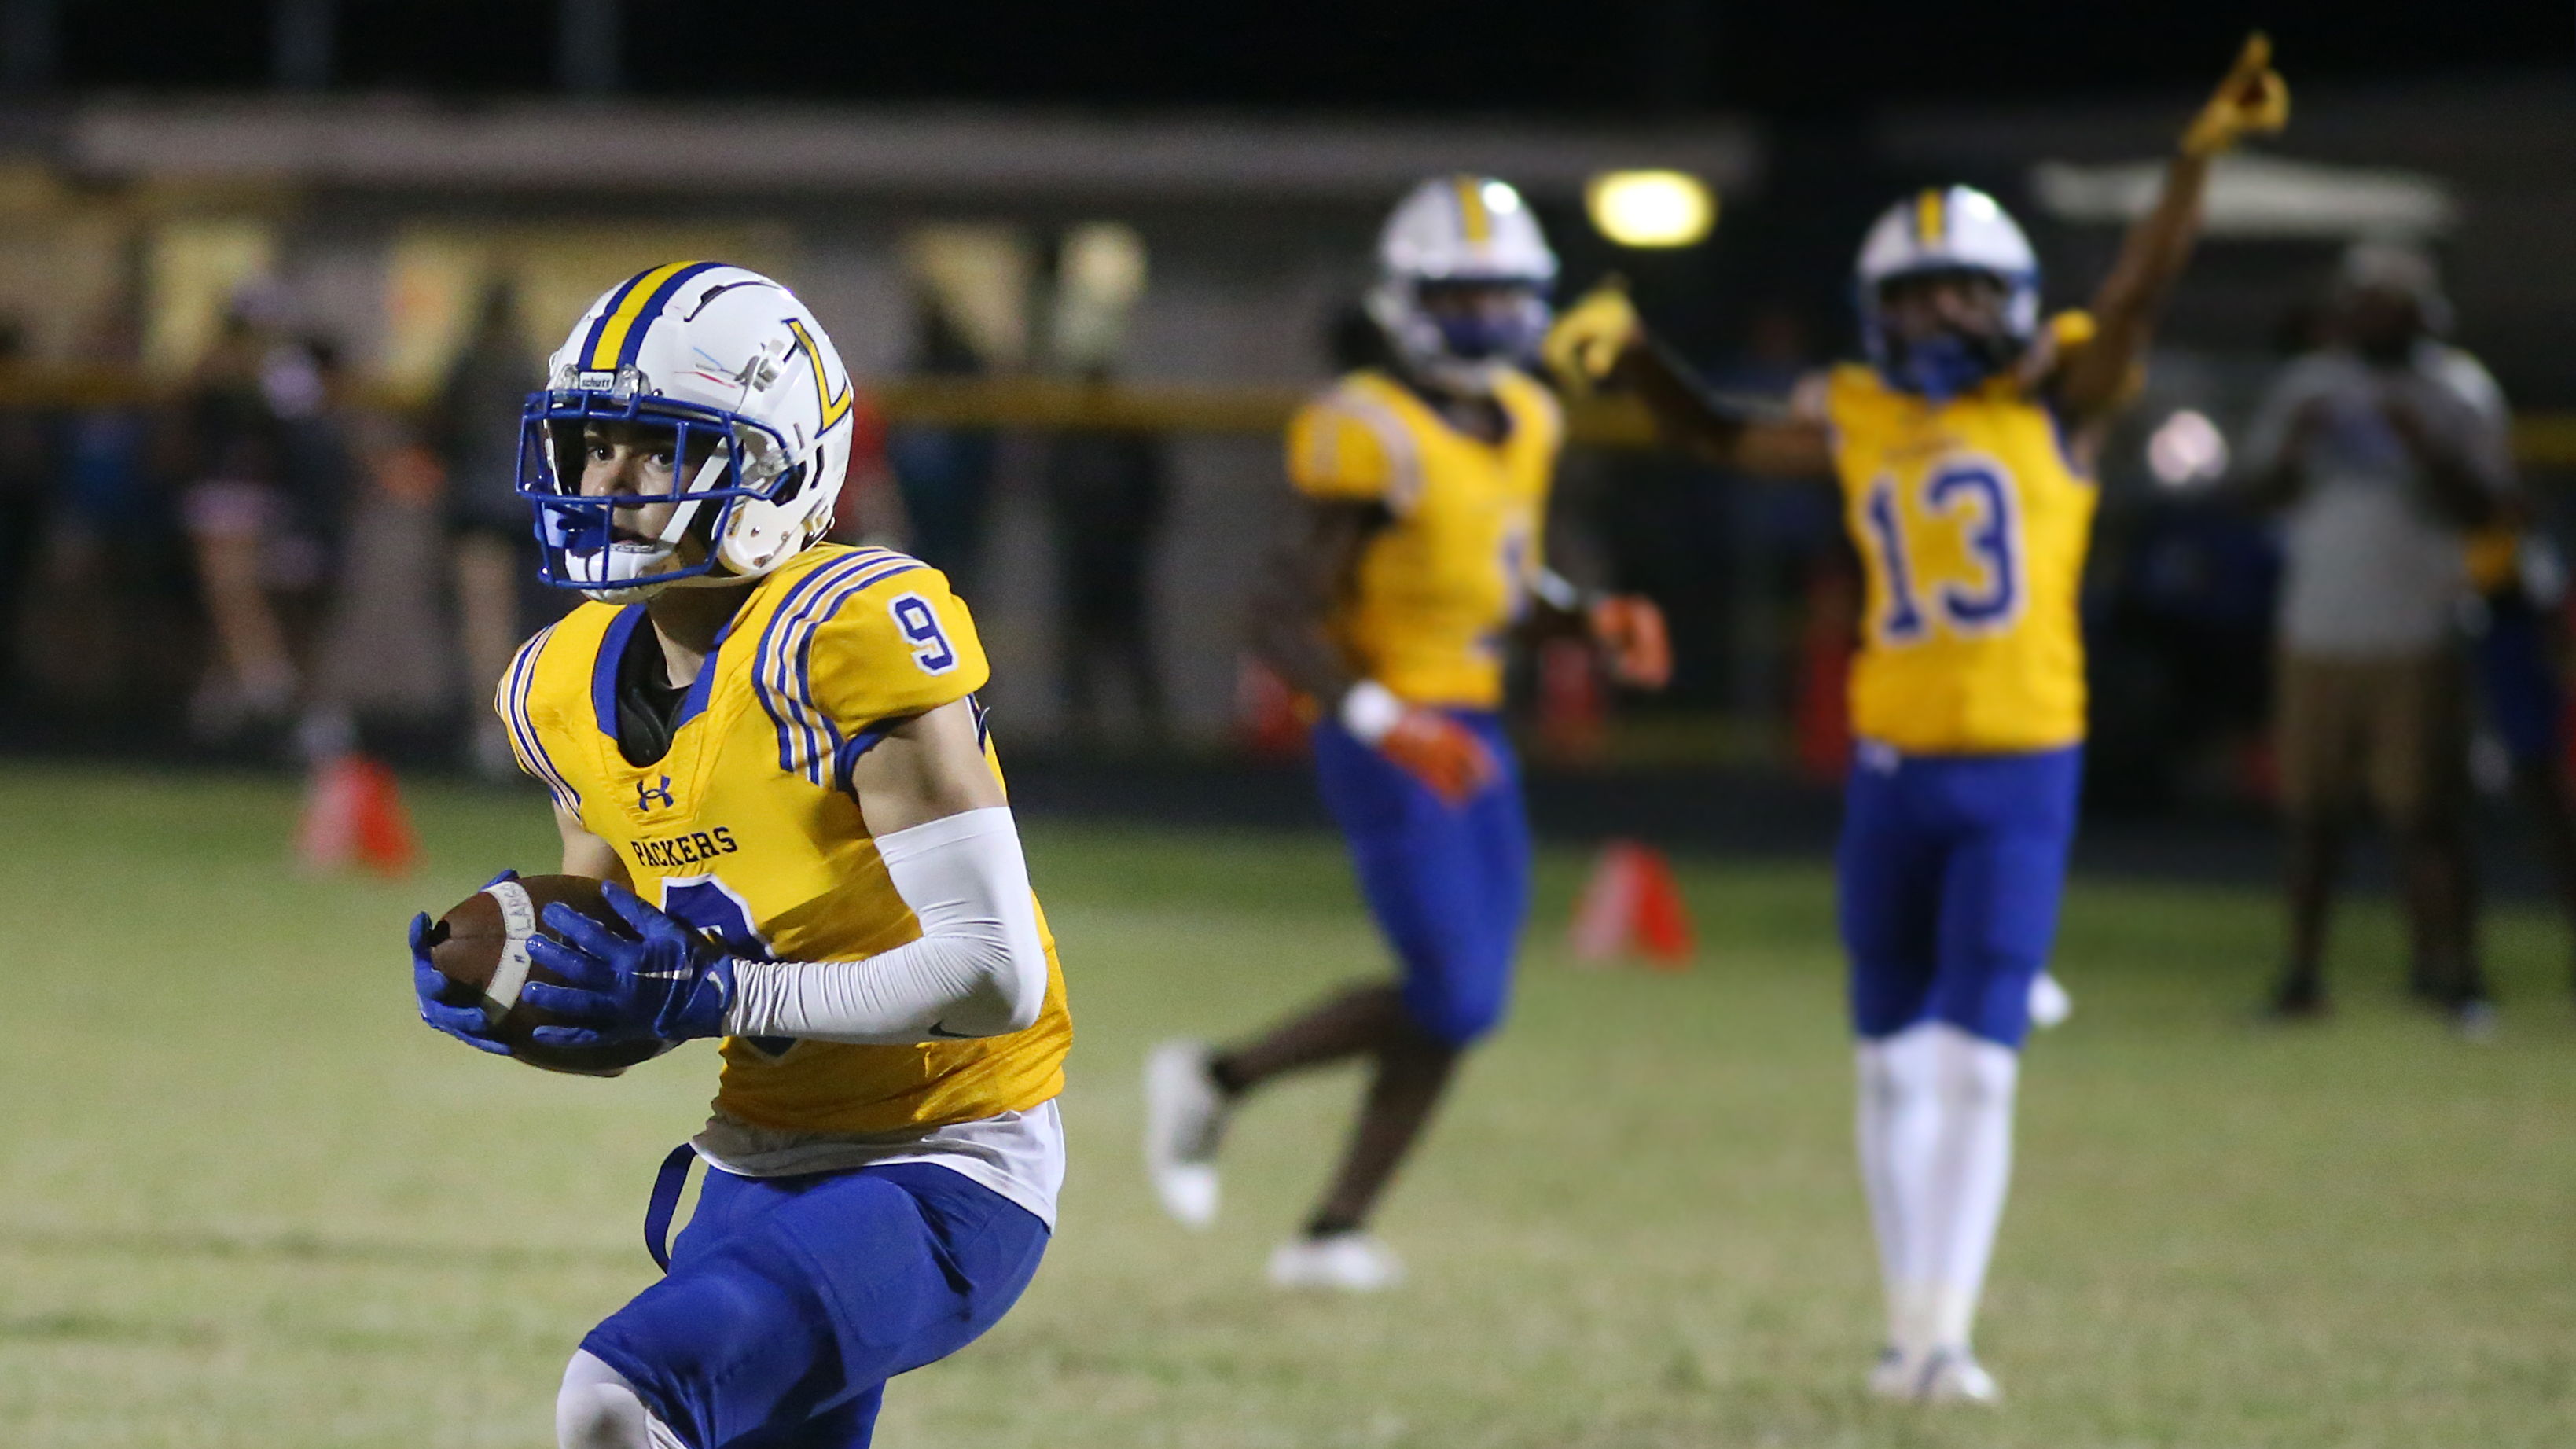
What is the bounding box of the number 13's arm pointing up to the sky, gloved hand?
[2056,34,2290,428]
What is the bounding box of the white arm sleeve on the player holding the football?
[724,804,1045,1044]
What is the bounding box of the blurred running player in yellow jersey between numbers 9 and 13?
[1146,175,1672,1289]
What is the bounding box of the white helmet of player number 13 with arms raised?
[1858,186,2040,397]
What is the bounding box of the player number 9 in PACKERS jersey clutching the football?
[412,263,1071,1449]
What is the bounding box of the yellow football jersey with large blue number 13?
[1826,314,2094,756]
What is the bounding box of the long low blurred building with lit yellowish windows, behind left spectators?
[0,95,1759,740]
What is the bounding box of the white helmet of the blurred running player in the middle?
[1368,175,1556,395]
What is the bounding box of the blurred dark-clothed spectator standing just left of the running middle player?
[1045,371,1170,742]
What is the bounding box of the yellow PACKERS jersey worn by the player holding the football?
[497,546,1071,1132]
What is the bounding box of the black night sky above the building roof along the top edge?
[40,0,2576,116]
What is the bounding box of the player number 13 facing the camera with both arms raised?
[1548,36,2288,1403]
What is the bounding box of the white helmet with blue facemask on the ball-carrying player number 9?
[518,260,855,603]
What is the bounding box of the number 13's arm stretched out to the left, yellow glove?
[1545,281,1834,480]
